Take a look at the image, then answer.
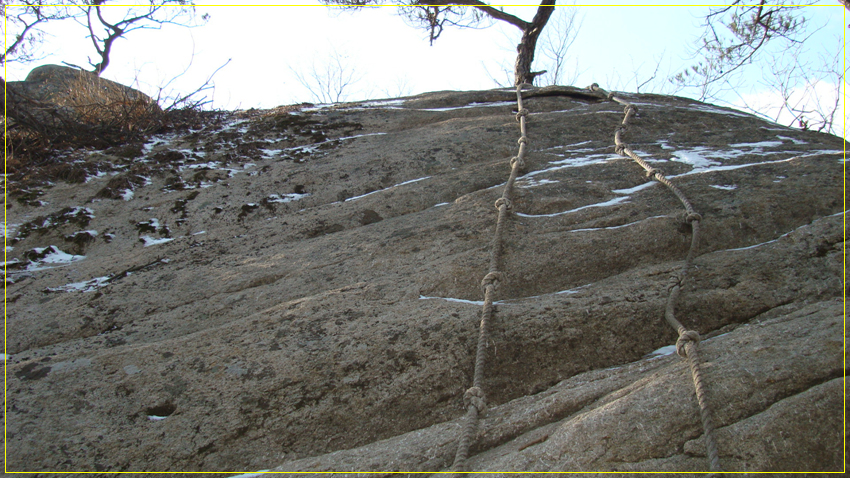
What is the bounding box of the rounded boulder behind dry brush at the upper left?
[5,65,159,128]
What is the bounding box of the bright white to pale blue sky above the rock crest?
[4,0,847,138]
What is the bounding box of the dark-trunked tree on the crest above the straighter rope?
[319,0,556,84]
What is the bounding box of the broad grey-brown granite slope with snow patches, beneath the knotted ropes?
[6,87,845,473]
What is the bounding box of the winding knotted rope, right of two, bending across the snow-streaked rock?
[588,83,722,473]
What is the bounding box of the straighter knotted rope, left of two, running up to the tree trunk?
[452,84,531,476]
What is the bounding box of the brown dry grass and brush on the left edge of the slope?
[3,70,220,197]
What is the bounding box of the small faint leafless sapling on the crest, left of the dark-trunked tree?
[289,49,362,103]
